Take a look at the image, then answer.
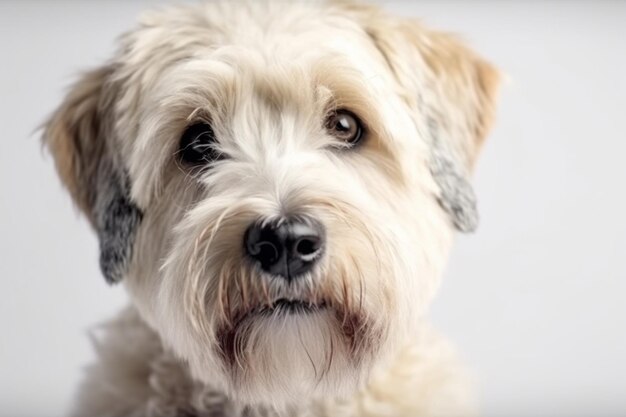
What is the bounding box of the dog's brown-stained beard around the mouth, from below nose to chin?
[207,268,380,401]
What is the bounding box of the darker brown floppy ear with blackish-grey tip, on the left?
[43,66,142,283]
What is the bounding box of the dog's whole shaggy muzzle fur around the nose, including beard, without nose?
[156,197,389,403]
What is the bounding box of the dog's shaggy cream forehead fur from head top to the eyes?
[118,2,422,206]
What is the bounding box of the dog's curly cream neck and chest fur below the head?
[74,308,471,417]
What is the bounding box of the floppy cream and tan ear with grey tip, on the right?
[345,4,500,232]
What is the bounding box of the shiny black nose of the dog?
[243,220,324,281]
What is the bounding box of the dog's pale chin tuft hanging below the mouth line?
[213,298,364,403]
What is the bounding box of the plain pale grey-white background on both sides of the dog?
[0,0,626,417]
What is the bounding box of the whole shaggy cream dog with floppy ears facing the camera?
[42,0,499,417]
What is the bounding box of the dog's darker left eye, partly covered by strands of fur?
[178,122,221,165]
